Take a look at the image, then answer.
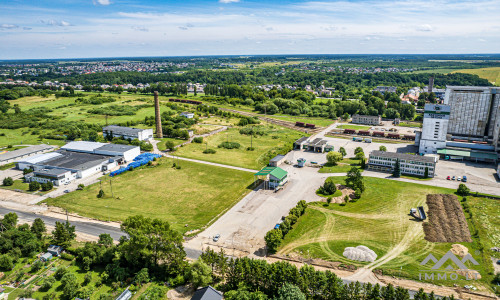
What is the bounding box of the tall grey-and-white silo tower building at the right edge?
[415,86,500,162]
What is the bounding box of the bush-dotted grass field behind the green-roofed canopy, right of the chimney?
[175,125,302,170]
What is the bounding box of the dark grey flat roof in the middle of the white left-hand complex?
[41,150,119,170]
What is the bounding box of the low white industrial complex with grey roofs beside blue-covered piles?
[16,141,140,186]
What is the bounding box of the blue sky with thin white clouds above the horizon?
[0,0,500,60]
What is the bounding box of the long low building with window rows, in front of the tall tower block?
[367,151,436,177]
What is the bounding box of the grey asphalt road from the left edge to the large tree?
[0,207,125,240]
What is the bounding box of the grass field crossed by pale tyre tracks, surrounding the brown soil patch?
[279,177,500,287]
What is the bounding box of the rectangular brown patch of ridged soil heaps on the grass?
[423,194,472,243]
